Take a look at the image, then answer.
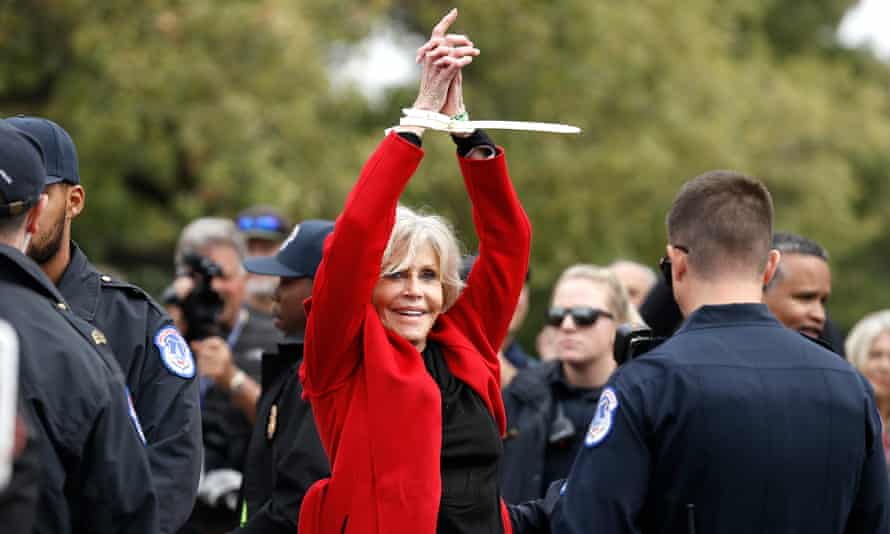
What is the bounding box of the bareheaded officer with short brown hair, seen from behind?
[552,171,890,534]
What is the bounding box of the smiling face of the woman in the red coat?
[371,244,444,351]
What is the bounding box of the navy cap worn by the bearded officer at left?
[6,115,80,185]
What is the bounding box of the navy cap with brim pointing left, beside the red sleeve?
[244,219,334,278]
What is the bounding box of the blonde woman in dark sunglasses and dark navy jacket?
[501,265,643,503]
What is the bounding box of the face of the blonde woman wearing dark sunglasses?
[552,278,615,364]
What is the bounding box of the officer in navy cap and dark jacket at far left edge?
[0,123,158,534]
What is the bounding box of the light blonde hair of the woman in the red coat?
[380,206,464,311]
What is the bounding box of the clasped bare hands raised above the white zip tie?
[414,9,479,115]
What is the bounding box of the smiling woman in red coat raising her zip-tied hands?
[299,10,531,534]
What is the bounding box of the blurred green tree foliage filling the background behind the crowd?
[0,0,890,344]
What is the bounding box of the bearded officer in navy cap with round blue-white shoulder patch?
[7,117,202,533]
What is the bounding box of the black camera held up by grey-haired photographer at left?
[179,254,223,341]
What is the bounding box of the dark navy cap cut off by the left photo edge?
[0,121,46,217]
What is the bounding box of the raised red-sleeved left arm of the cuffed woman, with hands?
[303,6,479,395]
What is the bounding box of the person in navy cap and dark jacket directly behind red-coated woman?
[235,220,334,534]
